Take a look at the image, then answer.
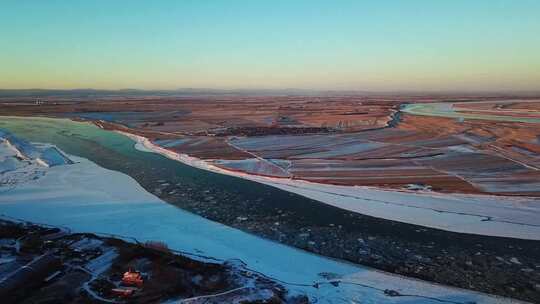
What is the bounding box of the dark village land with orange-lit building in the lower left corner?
[0,219,300,304]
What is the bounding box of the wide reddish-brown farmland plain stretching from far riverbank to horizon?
[0,96,540,196]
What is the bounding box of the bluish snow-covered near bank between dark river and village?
[0,134,519,304]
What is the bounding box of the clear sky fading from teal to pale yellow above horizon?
[0,0,540,91]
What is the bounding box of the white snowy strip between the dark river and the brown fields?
[122,132,540,240]
